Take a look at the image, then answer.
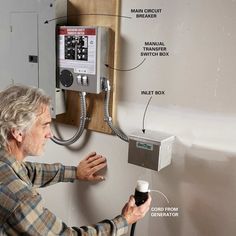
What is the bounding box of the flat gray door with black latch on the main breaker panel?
[10,12,39,87]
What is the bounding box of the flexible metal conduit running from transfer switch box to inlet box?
[103,78,129,142]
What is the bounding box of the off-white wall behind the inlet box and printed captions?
[36,0,236,236]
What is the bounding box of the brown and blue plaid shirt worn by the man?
[0,150,128,236]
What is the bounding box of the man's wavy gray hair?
[0,85,50,149]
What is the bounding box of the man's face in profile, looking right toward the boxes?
[22,105,52,157]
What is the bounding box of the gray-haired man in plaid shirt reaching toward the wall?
[0,86,151,236]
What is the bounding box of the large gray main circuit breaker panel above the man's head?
[0,0,67,117]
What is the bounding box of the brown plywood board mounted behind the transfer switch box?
[57,0,120,133]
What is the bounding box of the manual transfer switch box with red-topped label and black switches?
[58,26,109,94]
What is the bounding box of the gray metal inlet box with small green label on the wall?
[128,130,175,171]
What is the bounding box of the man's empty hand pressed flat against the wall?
[76,152,107,181]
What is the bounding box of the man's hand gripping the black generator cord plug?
[122,194,152,224]
